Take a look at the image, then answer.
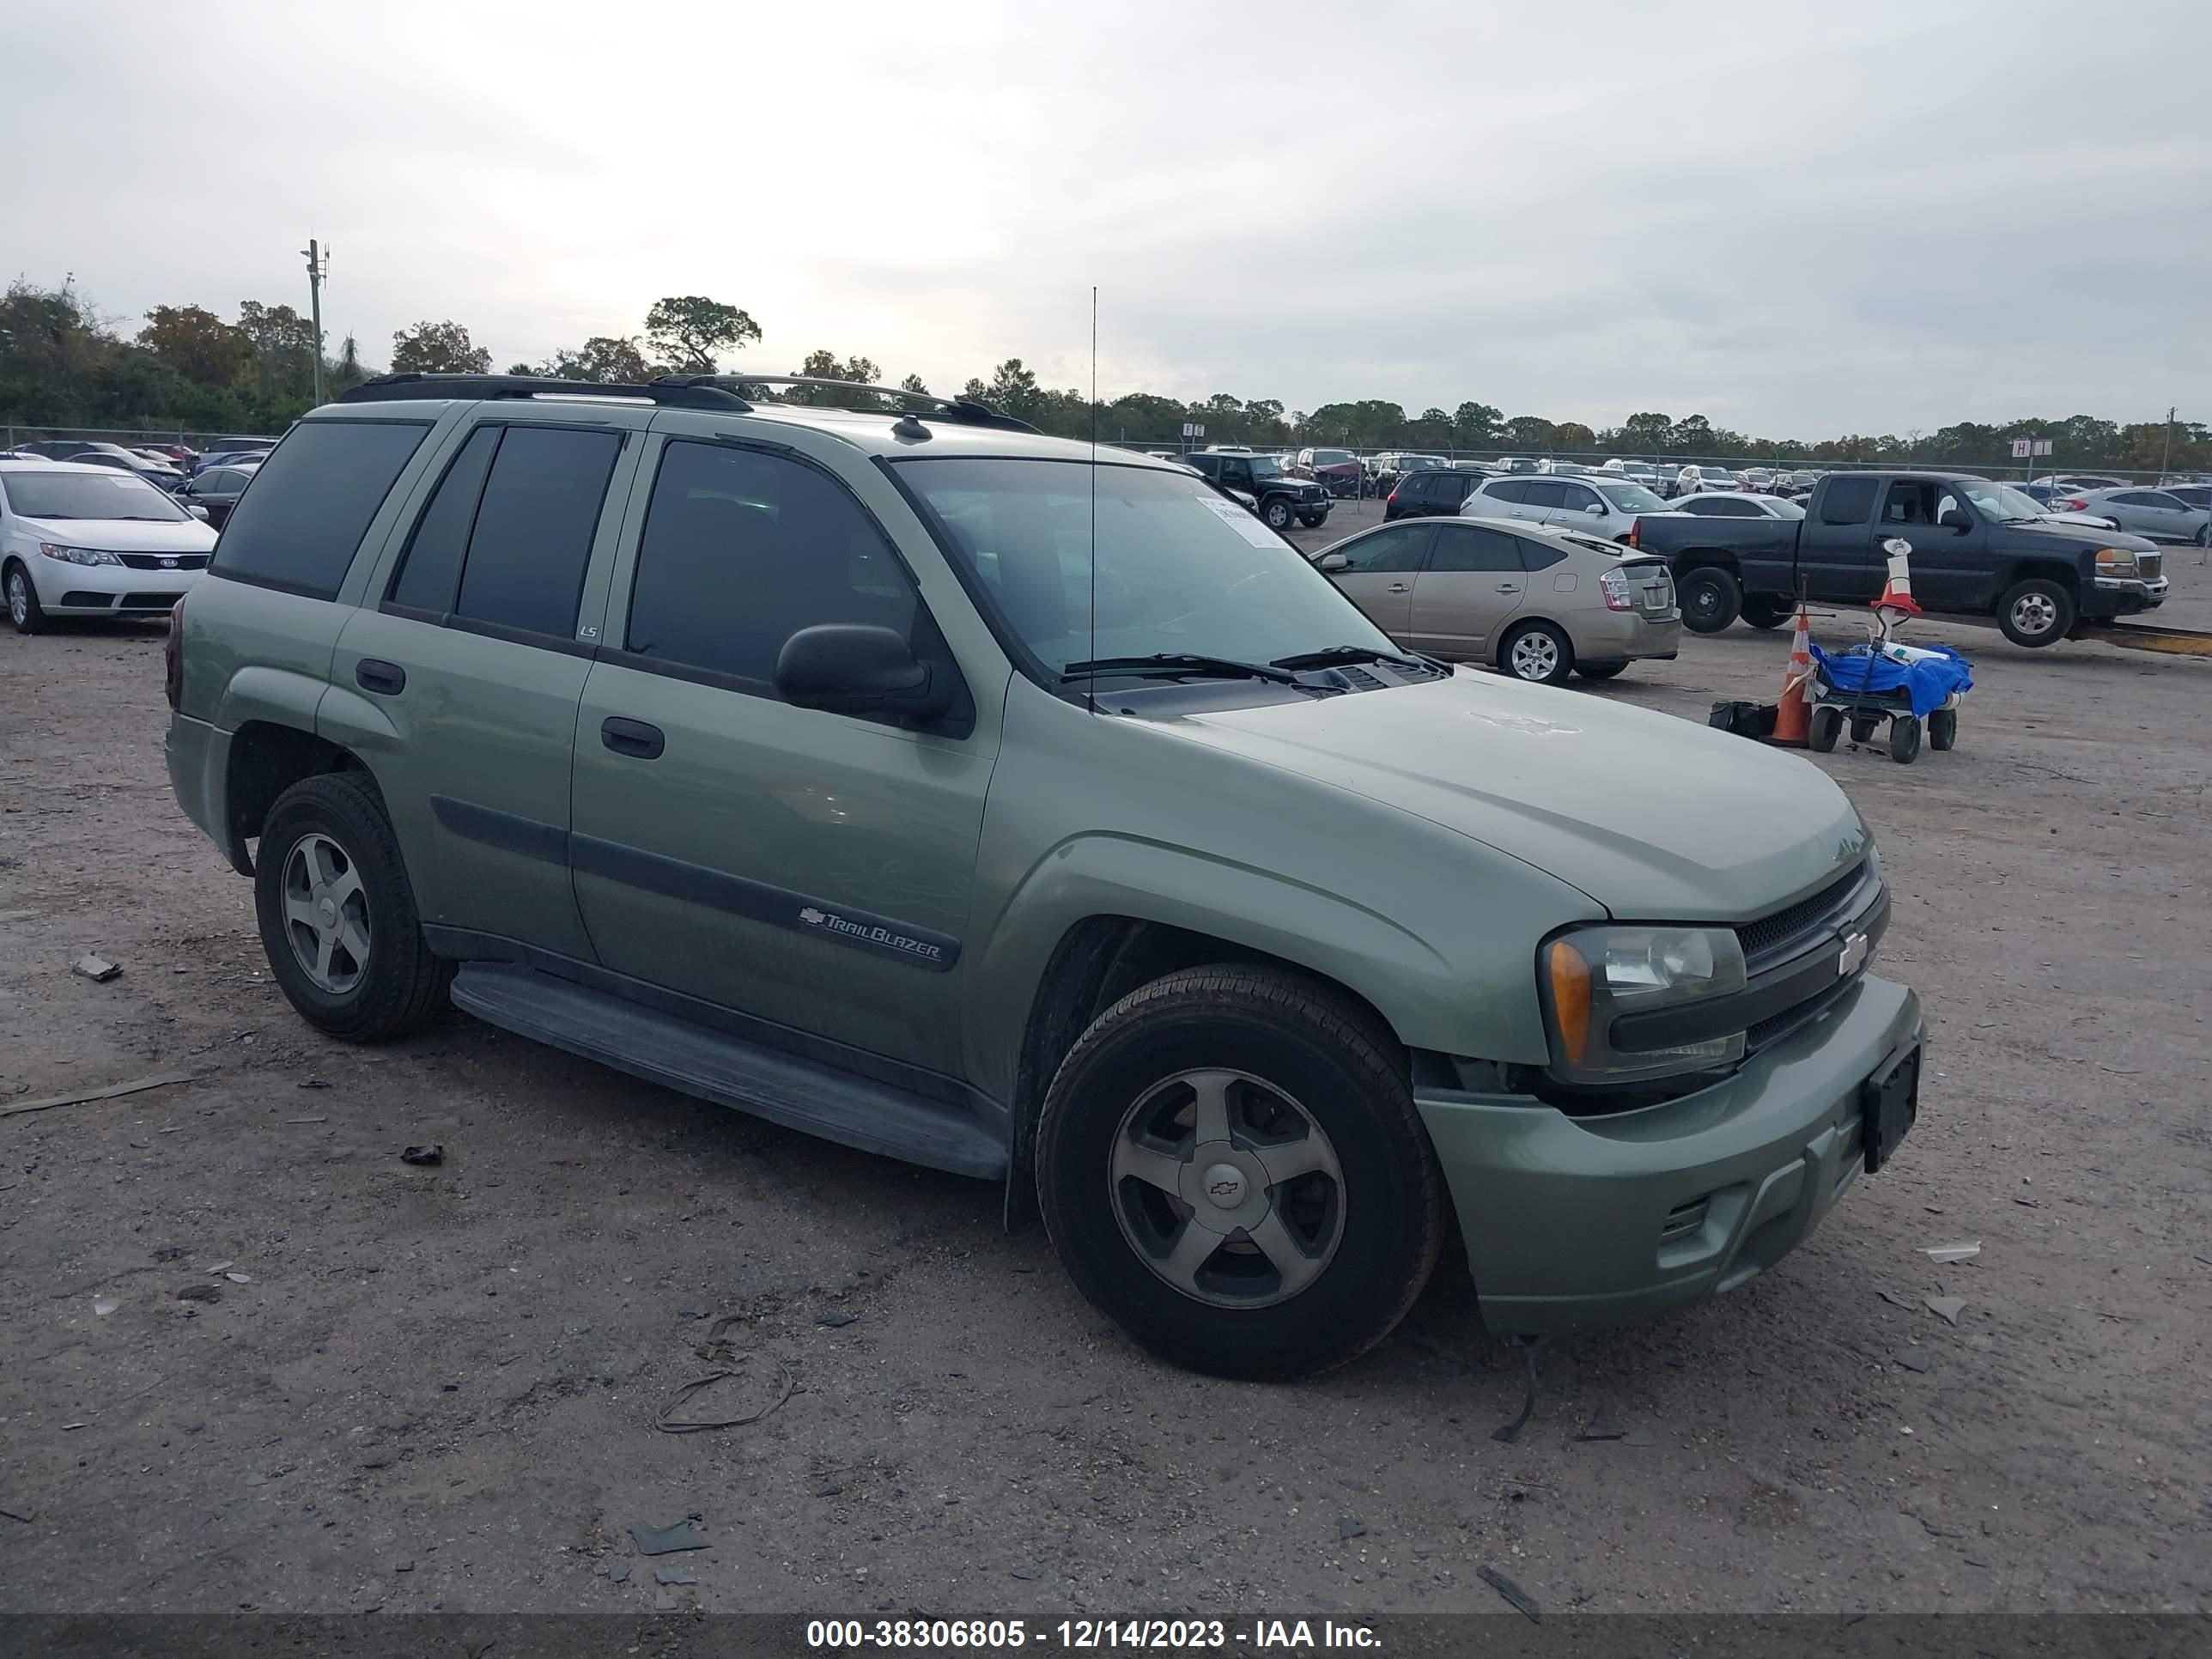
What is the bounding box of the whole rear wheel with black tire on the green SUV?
[254,772,453,1042]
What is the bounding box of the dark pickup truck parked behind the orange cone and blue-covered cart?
[1628,471,2166,646]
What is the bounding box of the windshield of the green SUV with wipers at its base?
[898,460,1394,675]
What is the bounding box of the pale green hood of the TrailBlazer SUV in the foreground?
[1172,668,1871,922]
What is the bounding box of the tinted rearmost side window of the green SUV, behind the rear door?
[215,420,429,599]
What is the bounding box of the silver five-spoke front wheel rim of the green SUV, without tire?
[1109,1071,1345,1307]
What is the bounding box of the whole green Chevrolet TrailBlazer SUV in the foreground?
[168,376,1920,1376]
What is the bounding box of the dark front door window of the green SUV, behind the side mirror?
[623,442,921,688]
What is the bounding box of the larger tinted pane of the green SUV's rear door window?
[453,427,622,639]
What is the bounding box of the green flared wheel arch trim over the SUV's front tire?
[964,832,1460,1099]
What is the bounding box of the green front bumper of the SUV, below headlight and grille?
[1416,975,1923,1336]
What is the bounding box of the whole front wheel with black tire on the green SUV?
[1037,964,1444,1378]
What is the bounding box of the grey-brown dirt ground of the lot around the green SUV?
[0,526,2212,1617]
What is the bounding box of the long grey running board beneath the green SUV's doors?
[453,963,1006,1182]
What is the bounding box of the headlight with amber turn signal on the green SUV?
[1537,927,1745,1084]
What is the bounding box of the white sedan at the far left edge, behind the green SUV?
[0,456,215,633]
